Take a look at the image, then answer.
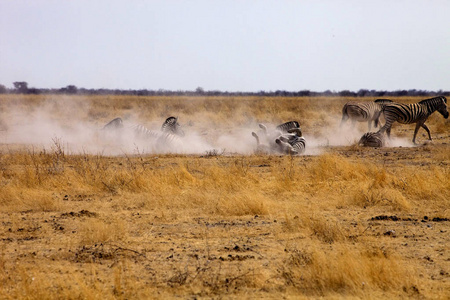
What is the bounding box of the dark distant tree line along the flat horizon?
[0,81,450,97]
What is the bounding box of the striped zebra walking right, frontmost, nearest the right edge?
[379,96,449,144]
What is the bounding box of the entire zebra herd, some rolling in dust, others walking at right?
[102,96,449,155]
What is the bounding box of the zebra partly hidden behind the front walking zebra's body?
[340,99,393,131]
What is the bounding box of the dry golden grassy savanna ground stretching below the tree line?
[0,95,450,299]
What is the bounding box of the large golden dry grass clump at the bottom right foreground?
[281,244,417,297]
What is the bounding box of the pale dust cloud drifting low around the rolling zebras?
[0,101,413,155]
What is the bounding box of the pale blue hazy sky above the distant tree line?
[0,0,450,91]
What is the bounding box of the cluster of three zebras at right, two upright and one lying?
[341,96,449,147]
